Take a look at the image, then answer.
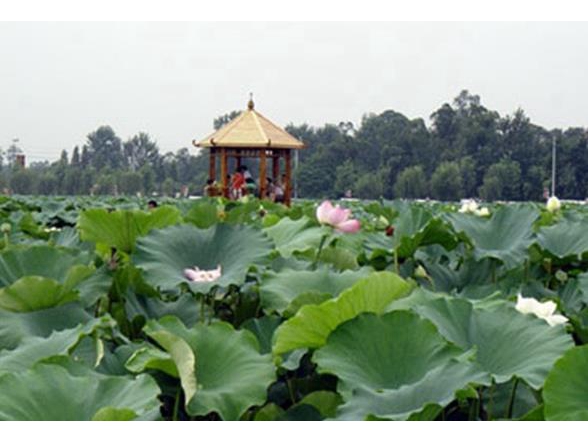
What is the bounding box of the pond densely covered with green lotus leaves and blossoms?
[0,197,588,420]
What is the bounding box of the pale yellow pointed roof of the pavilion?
[193,100,304,149]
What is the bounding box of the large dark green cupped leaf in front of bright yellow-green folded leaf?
[313,311,487,419]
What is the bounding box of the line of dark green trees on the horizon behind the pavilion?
[0,90,588,201]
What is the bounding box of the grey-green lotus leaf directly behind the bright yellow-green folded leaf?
[260,267,370,314]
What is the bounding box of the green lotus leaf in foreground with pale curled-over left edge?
[145,316,275,420]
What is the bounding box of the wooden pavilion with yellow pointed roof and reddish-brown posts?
[192,99,305,205]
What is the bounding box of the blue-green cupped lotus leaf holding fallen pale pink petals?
[134,224,271,293]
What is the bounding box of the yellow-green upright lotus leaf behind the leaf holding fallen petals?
[78,206,182,253]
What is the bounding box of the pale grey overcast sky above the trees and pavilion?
[0,22,588,162]
